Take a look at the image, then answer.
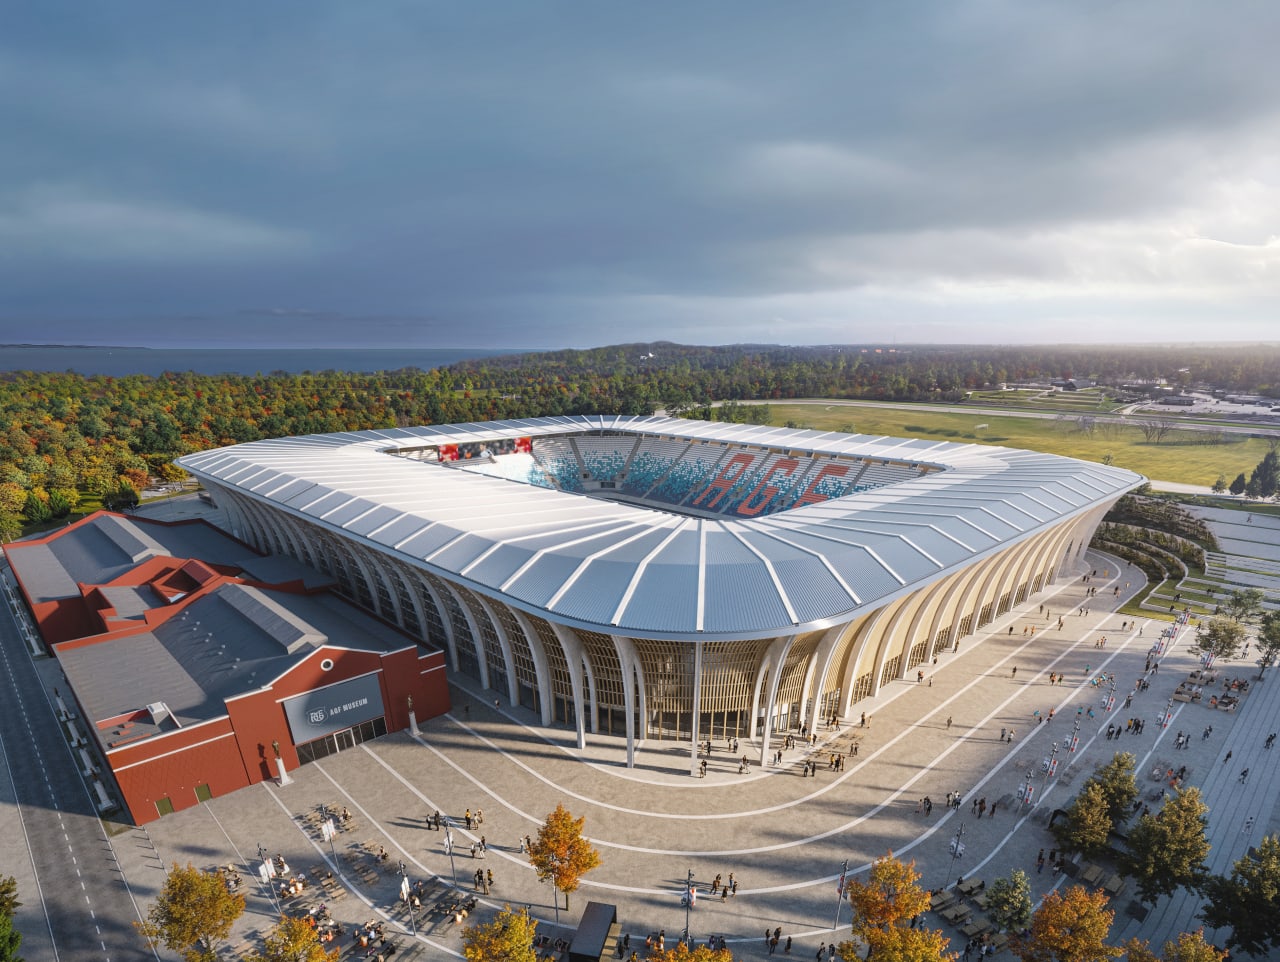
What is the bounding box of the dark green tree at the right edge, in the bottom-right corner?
[1199,835,1280,956]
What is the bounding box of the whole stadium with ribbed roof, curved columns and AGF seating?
[179,416,1144,765]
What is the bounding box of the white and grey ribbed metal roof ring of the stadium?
[179,416,1144,638]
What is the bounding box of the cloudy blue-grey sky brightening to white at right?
[0,0,1280,349]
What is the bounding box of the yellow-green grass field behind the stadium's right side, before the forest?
[769,402,1267,486]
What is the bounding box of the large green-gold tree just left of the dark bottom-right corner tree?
[1120,788,1208,903]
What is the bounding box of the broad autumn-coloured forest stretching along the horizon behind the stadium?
[0,342,1280,537]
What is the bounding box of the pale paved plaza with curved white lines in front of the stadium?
[6,511,1280,959]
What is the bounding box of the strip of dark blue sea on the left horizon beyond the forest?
[0,344,525,377]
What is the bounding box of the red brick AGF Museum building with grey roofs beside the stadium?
[5,512,449,824]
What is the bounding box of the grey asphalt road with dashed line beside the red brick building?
[0,567,156,962]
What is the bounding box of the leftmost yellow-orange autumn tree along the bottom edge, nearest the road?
[133,862,244,962]
